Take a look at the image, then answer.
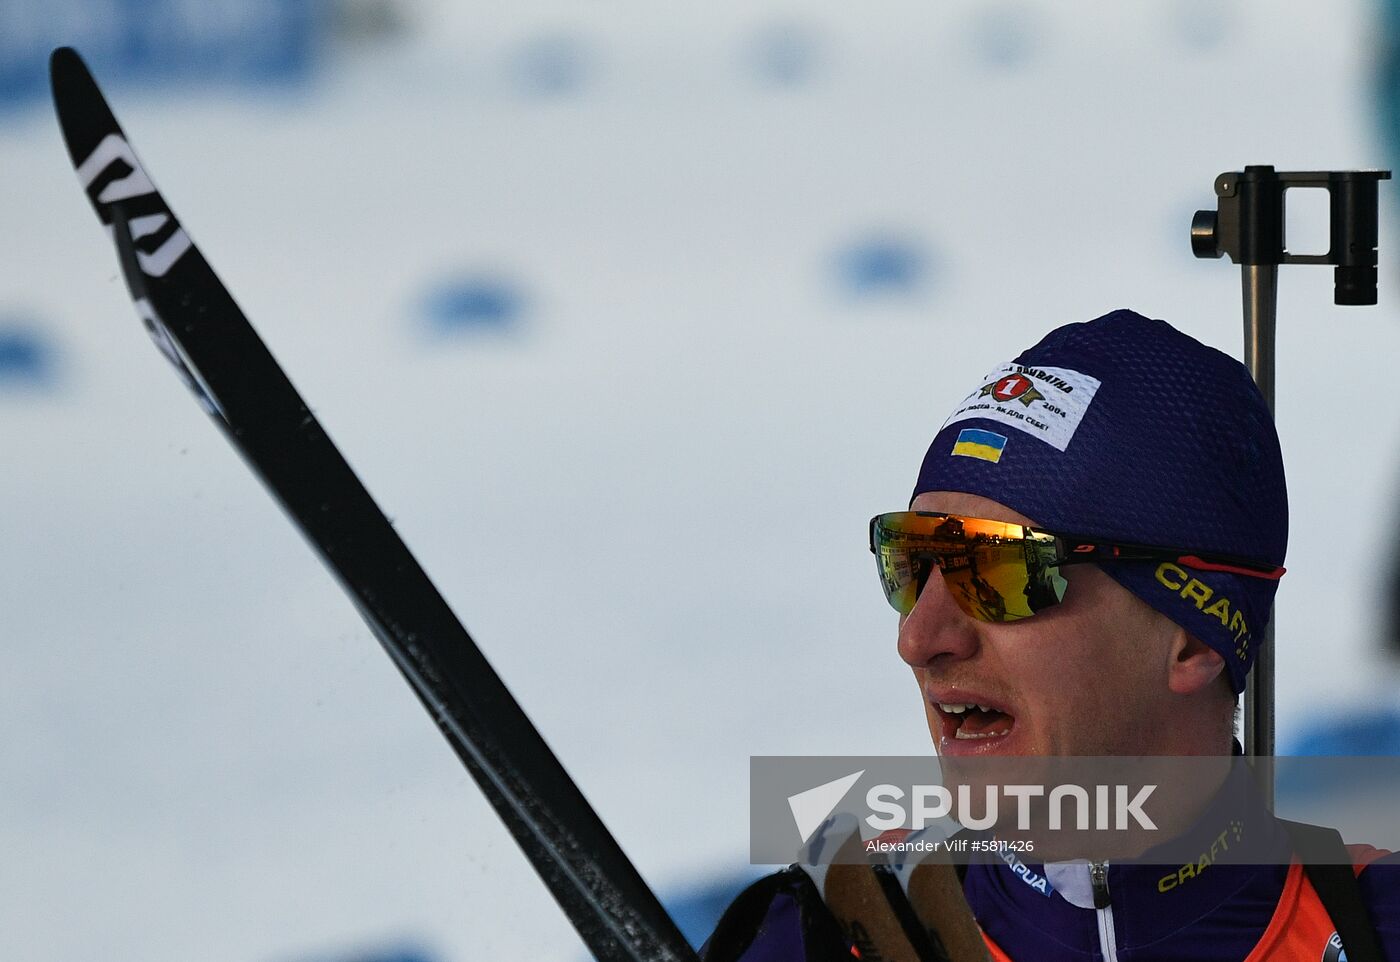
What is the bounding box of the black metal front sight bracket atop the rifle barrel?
[1191,165,1390,305]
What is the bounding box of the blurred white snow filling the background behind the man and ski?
[0,0,1400,962]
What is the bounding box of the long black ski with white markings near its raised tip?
[50,48,694,962]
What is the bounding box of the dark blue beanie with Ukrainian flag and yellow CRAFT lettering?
[914,311,1288,692]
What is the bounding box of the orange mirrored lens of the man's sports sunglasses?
[871,511,1065,622]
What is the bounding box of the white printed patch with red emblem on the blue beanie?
[944,363,1099,451]
